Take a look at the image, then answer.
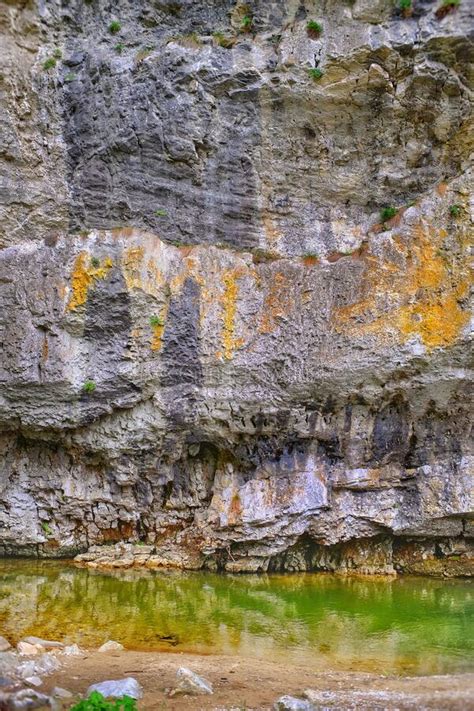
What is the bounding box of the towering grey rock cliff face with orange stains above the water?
[0,0,474,575]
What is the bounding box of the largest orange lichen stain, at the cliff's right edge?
[335,218,471,349]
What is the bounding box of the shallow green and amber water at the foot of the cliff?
[0,560,474,674]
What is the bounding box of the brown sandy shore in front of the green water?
[41,651,474,711]
